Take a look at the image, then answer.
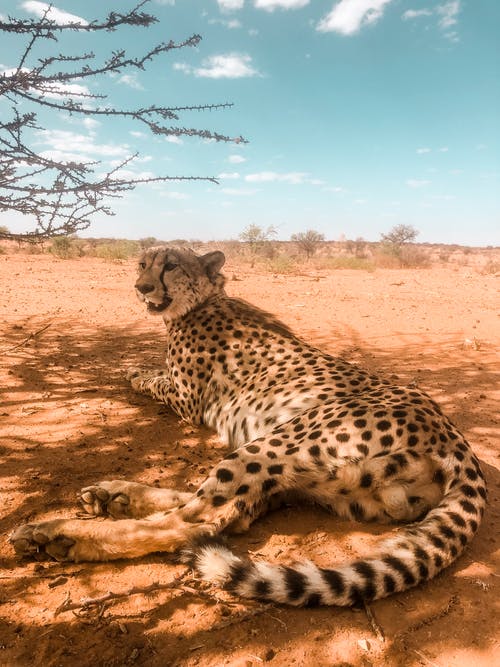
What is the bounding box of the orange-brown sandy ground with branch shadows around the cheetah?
[0,254,500,667]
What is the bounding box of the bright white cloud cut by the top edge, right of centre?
[316,0,392,35]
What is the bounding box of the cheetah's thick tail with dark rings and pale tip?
[182,477,486,607]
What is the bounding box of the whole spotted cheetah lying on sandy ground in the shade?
[10,247,486,606]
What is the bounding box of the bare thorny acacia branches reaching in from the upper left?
[0,0,245,242]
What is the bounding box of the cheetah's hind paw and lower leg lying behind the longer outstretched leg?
[79,479,192,519]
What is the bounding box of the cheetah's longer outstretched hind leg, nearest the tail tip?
[10,444,294,561]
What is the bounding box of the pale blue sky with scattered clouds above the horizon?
[0,0,500,245]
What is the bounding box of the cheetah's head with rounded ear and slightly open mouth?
[135,247,225,320]
